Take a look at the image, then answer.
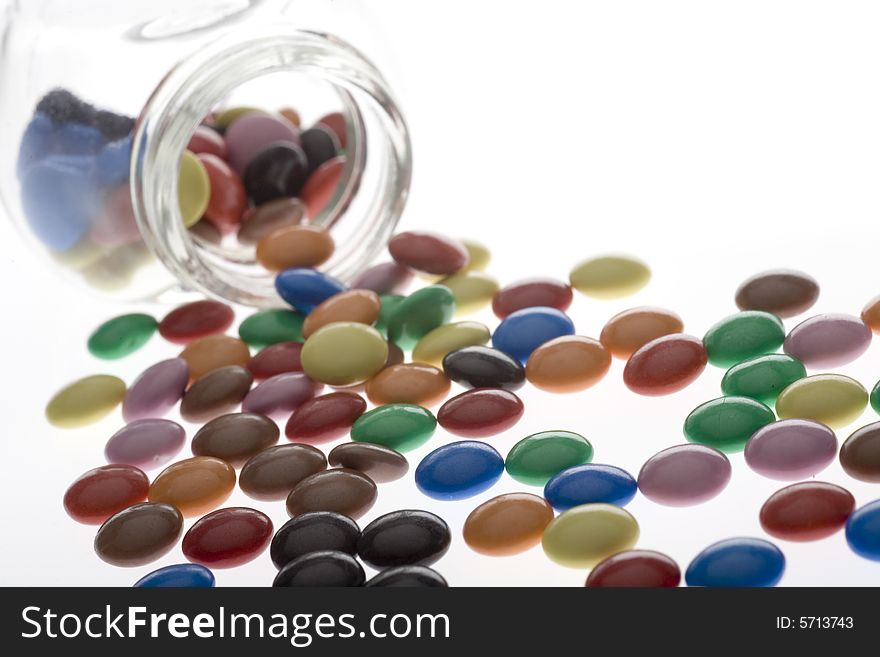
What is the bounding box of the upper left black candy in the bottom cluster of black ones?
[269,511,361,568]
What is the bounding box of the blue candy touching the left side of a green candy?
[415,440,504,500]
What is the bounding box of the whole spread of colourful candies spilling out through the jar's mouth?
[46,95,880,586]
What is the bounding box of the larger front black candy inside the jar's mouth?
[244,141,309,205]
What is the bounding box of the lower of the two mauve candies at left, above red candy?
[104,419,186,470]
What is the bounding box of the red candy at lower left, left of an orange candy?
[64,465,150,525]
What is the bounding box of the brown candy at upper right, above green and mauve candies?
[736,269,819,319]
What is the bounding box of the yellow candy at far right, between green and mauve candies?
[776,374,868,429]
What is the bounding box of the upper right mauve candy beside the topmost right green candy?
[783,314,871,369]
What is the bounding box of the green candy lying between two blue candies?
[504,431,593,486]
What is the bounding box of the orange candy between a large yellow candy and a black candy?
[366,363,450,406]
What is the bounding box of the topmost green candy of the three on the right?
[703,310,785,367]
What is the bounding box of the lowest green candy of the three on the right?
[684,397,776,452]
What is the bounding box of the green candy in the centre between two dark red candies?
[351,404,437,452]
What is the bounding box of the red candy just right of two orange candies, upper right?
[623,333,707,397]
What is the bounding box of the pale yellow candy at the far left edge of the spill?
[46,374,125,429]
